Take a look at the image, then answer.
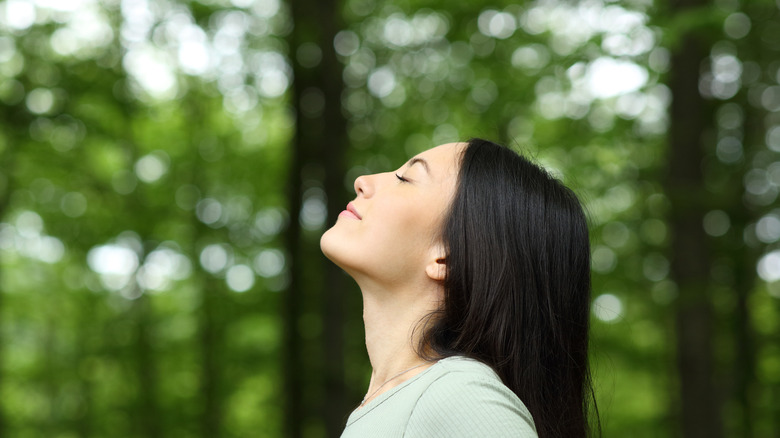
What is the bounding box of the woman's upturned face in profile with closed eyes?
[320,143,465,284]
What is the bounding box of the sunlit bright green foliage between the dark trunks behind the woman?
[0,0,780,436]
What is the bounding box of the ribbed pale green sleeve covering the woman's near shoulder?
[404,373,538,438]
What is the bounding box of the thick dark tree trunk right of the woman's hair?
[666,0,723,438]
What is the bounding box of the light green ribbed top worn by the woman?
[341,356,537,438]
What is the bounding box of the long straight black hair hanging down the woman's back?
[420,139,598,438]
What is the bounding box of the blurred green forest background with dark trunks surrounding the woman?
[0,0,780,438]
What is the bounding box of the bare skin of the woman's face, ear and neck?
[320,143,466,403]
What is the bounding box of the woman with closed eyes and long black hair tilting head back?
[320,139,592,438]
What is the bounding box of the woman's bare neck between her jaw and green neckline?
[361,278,439,402]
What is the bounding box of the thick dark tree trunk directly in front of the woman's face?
[283,0,348,438]
